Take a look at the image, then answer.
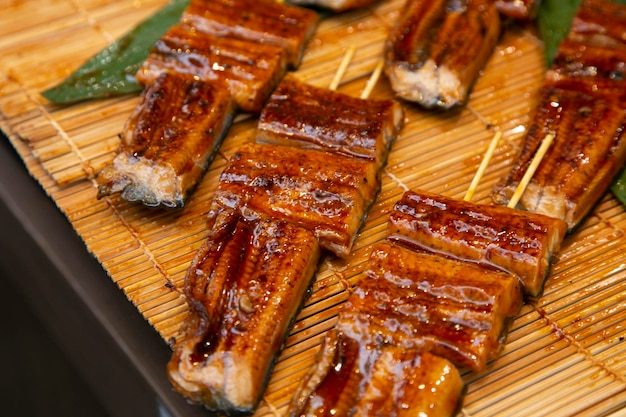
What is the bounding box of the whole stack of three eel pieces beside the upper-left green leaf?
[96,0,319,208]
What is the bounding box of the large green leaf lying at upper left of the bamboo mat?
[42,0,189,104]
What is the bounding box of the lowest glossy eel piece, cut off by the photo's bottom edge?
[287,330,465,417]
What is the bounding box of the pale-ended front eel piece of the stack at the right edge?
[494,88,626,230]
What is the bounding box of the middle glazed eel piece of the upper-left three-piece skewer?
[136,24,287,113]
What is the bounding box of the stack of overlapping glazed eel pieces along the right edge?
[493,0,626,230]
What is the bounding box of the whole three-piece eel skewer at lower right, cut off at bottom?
[289,190,566,417]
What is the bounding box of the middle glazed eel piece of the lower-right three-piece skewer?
[336,242,522,371]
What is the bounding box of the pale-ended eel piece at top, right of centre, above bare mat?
[385,0,501,109]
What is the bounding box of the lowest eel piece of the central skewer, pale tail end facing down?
[167,210,320,414]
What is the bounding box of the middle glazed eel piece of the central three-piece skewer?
[208,144,379,257]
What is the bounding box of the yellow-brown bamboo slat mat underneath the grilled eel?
[0,0,626,417]
